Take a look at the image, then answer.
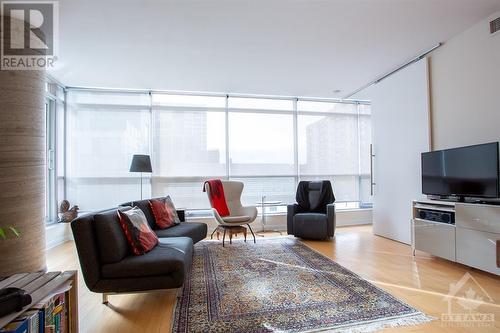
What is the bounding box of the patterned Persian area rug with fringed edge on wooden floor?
[173,238,431,332]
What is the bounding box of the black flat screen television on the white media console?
[422,142,499,199]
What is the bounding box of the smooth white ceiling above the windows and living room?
[51,0,500,97]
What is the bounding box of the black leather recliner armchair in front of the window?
[286,180,335,239]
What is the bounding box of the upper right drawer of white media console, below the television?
[455,203,500,234]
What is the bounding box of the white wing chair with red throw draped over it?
[203,180,257,245]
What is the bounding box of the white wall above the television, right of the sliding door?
[430,12,500,149]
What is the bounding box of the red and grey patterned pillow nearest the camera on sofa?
[118,207,158,255]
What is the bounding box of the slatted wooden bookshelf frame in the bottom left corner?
[0,271,78,333]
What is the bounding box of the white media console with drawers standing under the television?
[412,199,500,275]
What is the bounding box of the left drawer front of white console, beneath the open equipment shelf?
[413,219,455,261]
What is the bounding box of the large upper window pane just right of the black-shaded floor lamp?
[153,109,226,177]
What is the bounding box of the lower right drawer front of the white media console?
[456,228,500,275]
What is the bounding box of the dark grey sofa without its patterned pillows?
[71,200,207,304]
